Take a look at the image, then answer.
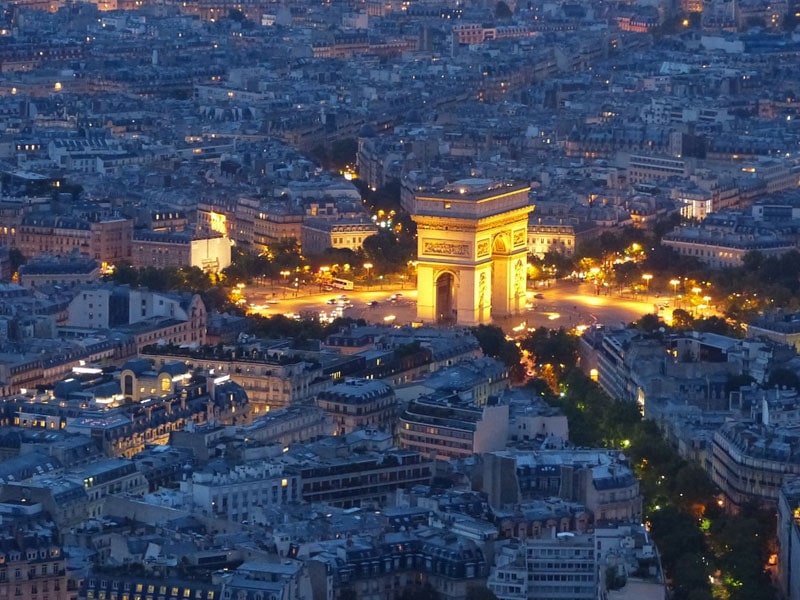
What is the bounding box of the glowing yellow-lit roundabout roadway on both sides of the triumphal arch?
[244,282,660,330]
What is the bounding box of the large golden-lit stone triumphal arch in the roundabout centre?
[413,179,533,325]
